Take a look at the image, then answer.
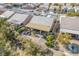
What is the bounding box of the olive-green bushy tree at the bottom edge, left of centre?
[25,40,41,56]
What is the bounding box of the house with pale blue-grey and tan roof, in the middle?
[26,16,55,32]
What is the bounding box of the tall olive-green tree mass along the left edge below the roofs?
[0,19,18,56]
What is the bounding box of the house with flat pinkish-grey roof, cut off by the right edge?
[60,16,79,39]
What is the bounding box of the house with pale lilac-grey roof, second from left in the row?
[8,13,32,25]
